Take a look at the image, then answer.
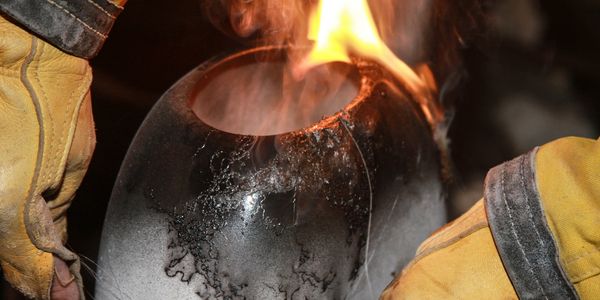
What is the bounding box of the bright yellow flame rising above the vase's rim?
[303,0,426,94]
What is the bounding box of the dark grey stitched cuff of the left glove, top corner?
[0,0,126,59]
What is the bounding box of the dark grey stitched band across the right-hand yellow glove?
[484,148,578,299]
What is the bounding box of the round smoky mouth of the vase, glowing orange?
[188,47,364,136]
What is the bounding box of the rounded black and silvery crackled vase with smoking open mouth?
[96,47,445,299]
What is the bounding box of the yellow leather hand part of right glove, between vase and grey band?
[381,200,517,300]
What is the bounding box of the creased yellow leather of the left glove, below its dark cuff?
[0,15,95,299]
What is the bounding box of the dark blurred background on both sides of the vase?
[0,0,600,300]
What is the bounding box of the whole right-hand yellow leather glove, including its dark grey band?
[381,137,600,299]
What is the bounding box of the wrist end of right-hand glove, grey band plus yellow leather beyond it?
[485,137,600,299]
